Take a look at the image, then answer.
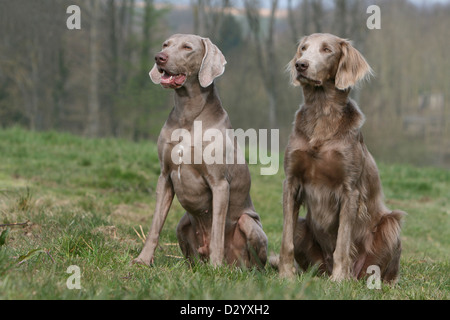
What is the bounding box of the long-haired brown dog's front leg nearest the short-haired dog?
[278,179,300,277]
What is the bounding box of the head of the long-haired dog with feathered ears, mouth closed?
[288,33,372,90]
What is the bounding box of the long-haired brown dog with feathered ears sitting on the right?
[278,34,405,281]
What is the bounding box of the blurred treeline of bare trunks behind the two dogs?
[0,0,450,167]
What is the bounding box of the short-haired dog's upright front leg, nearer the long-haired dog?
[209,180,230,267]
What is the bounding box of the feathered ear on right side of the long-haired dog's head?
[334,40,373,90]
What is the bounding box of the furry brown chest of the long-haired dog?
[287,102,364,189]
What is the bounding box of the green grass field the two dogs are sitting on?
[0,128,450,299]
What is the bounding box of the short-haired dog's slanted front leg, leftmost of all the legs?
[132,174,174,266]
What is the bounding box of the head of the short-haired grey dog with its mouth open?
[149,34,227,89]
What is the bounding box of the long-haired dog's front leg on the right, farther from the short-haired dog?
[331,190,359,281]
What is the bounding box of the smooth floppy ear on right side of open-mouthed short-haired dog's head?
[198,38,227,88]
